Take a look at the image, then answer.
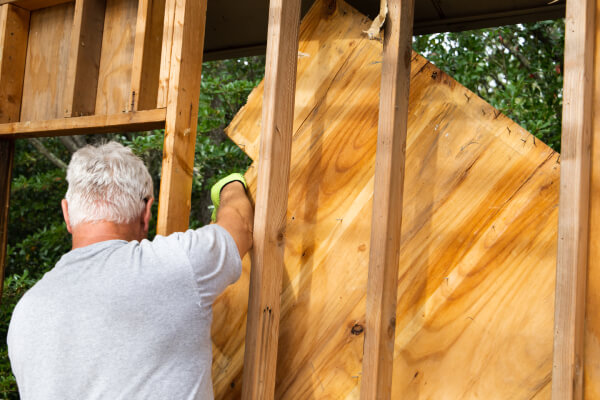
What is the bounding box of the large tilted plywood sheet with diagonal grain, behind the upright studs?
[213,1,560,399]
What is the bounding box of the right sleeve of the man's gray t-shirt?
[169,224,242,306]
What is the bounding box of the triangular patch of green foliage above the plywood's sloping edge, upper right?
[413,20,565,151]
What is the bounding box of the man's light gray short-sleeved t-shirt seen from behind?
[8,225,241,400]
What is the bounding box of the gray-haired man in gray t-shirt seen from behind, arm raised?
[8,142,253,400]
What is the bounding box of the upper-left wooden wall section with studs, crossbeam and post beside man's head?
[0,0,206,296]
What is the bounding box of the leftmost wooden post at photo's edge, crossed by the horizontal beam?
[0,4,29,296]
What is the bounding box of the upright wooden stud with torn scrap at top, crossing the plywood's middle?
[361,0,414,400]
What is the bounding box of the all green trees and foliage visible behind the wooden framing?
[0,20,564,399]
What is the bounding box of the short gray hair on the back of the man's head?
[65,142,153,226]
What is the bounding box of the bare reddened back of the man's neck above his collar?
[73,221,142,249]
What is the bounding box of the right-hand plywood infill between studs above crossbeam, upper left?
[95,0,138,115]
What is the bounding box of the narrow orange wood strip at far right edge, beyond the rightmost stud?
[583,0,600,400]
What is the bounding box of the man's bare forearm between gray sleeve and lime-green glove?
[217,181,254,258]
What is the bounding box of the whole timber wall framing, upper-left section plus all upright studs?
[0,0,600,400]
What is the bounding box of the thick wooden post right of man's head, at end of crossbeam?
[157,0,206,235]
